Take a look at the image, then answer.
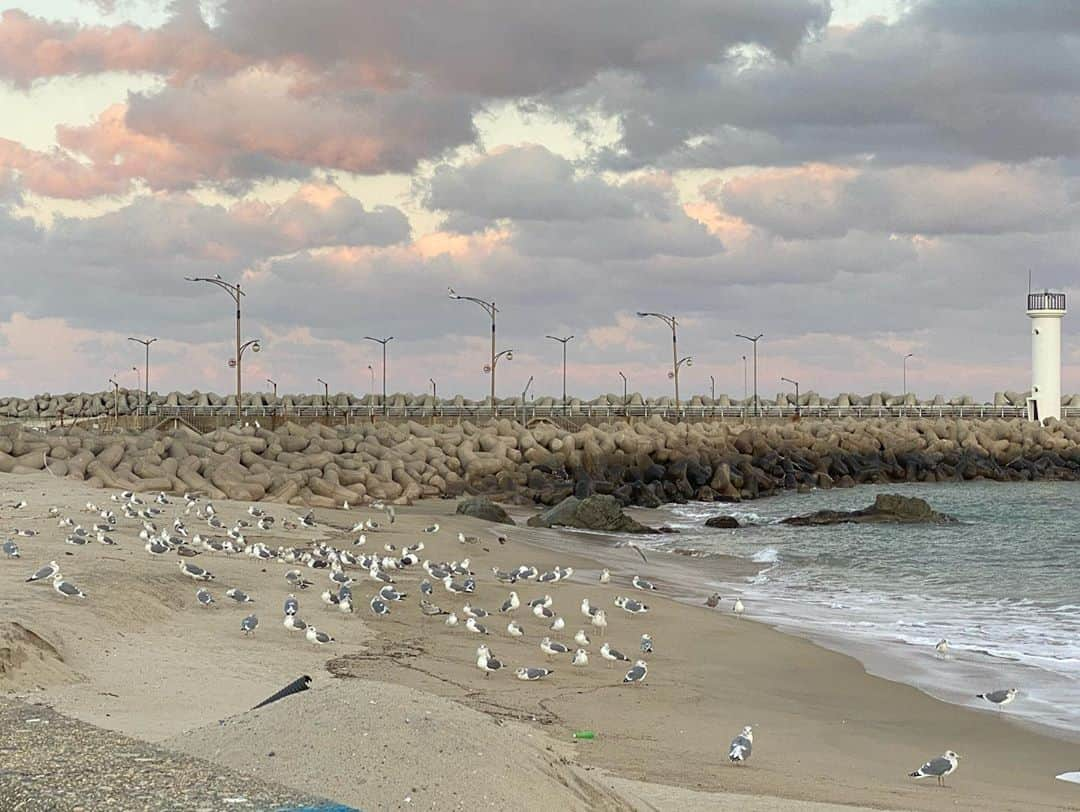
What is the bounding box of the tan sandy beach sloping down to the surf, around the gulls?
[0,474,1080,810]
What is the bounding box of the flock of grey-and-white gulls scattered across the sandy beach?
[0,491,1017,786]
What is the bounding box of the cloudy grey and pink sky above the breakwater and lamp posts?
[0,0,1080,396]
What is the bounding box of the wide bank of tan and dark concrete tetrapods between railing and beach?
[0,417,1080,506]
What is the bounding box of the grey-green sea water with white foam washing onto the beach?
[622,482,1080,737]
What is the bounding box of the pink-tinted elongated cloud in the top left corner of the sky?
[0,9,245,85]
